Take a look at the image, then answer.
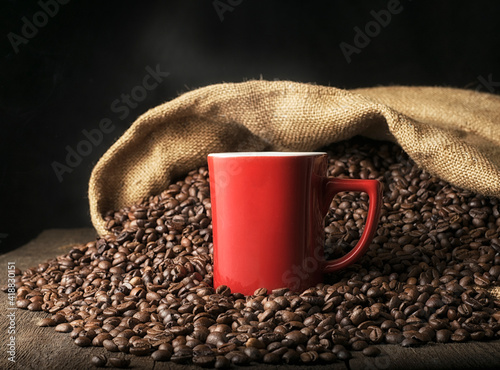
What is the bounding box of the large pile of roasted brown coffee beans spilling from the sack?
[4,138,500,368]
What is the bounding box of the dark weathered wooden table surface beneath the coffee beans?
[0,228,500,370]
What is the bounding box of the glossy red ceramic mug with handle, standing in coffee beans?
[208,152,382,295]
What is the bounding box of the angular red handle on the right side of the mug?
[323,177,382,273]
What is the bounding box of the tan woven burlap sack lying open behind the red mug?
[89,81,500,235]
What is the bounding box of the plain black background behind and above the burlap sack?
[0,0,500,251]
